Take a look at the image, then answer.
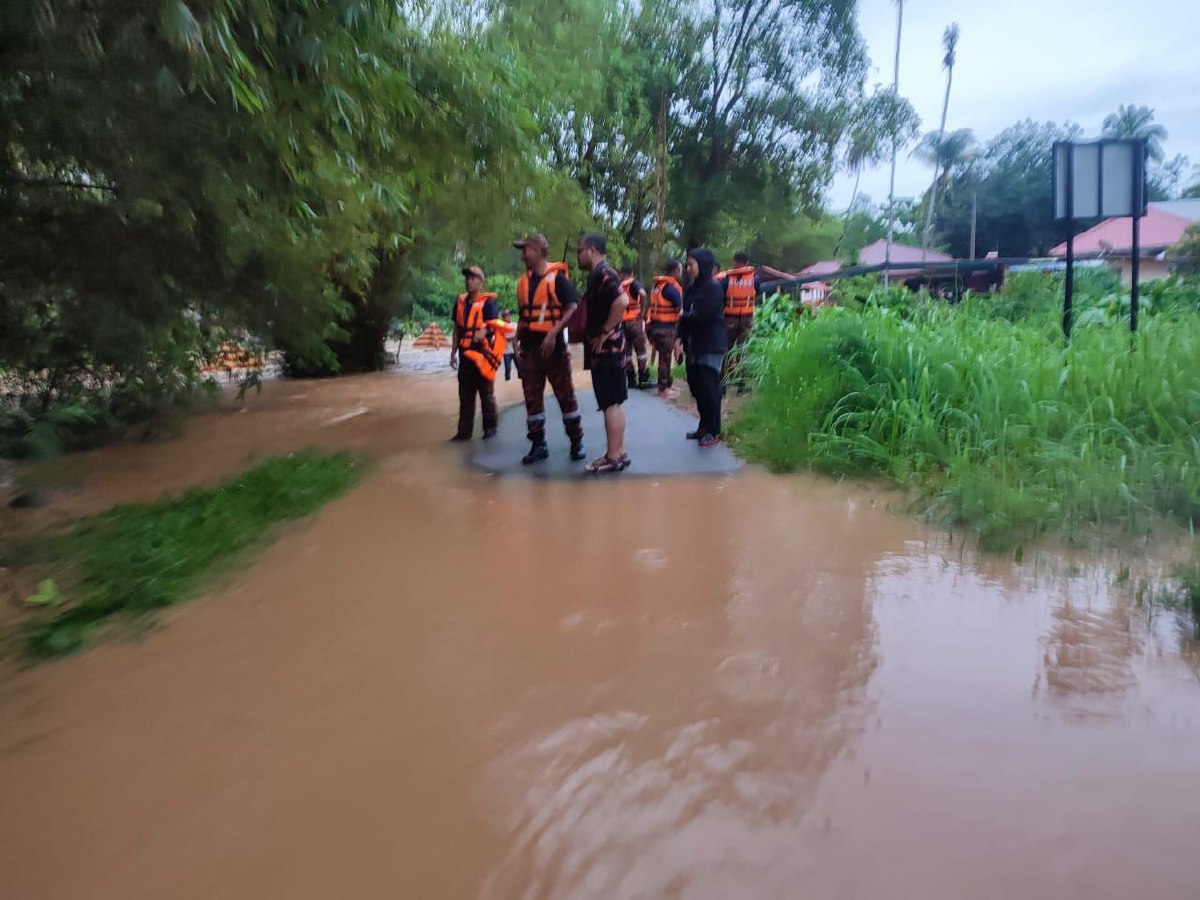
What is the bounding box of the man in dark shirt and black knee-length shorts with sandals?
[578,233,629,474]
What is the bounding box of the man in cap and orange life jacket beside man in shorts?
[512,234,584,466]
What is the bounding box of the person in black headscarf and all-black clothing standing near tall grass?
[679,247,728,448]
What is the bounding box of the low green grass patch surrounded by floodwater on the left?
[14,451,358,656]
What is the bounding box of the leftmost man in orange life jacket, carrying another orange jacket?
[450,265,503,440]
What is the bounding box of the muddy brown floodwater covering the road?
[0,362,1200,900]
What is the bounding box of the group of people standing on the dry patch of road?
[450,233,774,474]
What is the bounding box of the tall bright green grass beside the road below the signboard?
[733,300,1200,541]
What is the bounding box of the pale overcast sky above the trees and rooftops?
[829,0,1200,209]
